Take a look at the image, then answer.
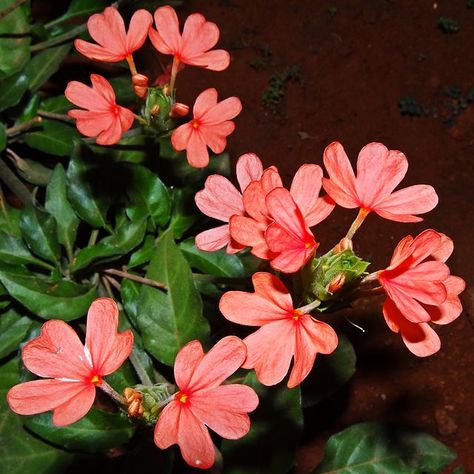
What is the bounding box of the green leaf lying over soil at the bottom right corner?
[313,422,456,474]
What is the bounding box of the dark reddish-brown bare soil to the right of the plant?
[178,0,474,474]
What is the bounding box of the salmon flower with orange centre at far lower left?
[7,298,133,426]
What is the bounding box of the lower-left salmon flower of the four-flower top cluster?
[64,74,134,145]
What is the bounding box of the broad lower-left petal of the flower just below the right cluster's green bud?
[243,318,295,385]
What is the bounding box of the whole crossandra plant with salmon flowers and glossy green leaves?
[0,0,465,474]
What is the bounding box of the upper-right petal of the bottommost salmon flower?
[188,336,246,392]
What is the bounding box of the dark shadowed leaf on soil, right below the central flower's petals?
[301,335,356,408]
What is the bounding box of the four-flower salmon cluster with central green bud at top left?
[65,6,242,168]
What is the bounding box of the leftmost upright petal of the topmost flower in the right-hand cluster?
[323,142,358,208]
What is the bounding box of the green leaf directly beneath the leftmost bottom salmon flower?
[24,408,135,453]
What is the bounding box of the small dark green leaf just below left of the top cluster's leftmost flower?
[23,119,79,156]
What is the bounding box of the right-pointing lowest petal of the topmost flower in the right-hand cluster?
[373,184,438,215]
